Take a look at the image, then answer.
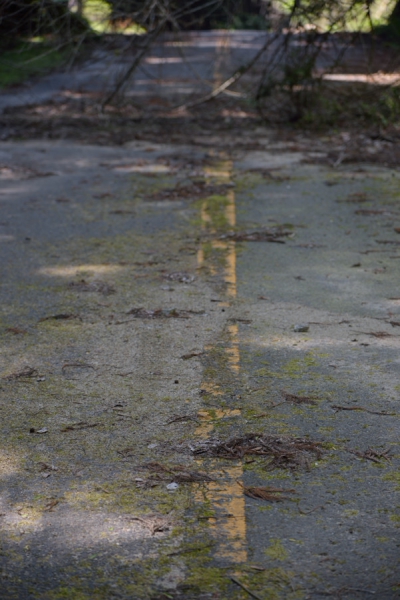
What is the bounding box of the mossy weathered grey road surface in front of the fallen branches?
[0,134,400,600]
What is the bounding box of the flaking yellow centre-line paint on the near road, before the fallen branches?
[196,160,247,564]
